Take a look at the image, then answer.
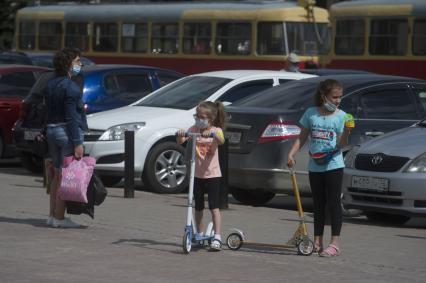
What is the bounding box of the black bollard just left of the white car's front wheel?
[124,131,135,198]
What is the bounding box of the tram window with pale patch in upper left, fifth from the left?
[121,23,148,53]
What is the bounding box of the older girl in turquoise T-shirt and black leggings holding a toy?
[287,79,354,257]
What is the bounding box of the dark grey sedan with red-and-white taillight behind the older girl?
[226,74,426,205]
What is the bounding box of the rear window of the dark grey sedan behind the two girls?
[232,80,317,110]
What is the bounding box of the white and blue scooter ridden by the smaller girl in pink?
[182,132,214,254]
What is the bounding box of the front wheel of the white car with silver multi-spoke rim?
[142,142,187,194]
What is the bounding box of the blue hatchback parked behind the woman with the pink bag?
[13,65,183,172]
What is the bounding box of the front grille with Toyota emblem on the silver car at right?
[355,153,410,172]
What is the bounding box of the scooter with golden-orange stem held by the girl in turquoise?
[226,167,314,256]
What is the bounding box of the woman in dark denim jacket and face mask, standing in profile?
[45,48,87,228]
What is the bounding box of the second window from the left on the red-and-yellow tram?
[38,22,62,50]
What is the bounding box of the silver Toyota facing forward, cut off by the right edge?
[343,120,426,224]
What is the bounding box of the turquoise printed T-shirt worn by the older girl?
[299,107,346,172]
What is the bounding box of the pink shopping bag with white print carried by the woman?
[58,156,96,203]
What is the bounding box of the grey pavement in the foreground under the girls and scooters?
[0,161,426,283]
